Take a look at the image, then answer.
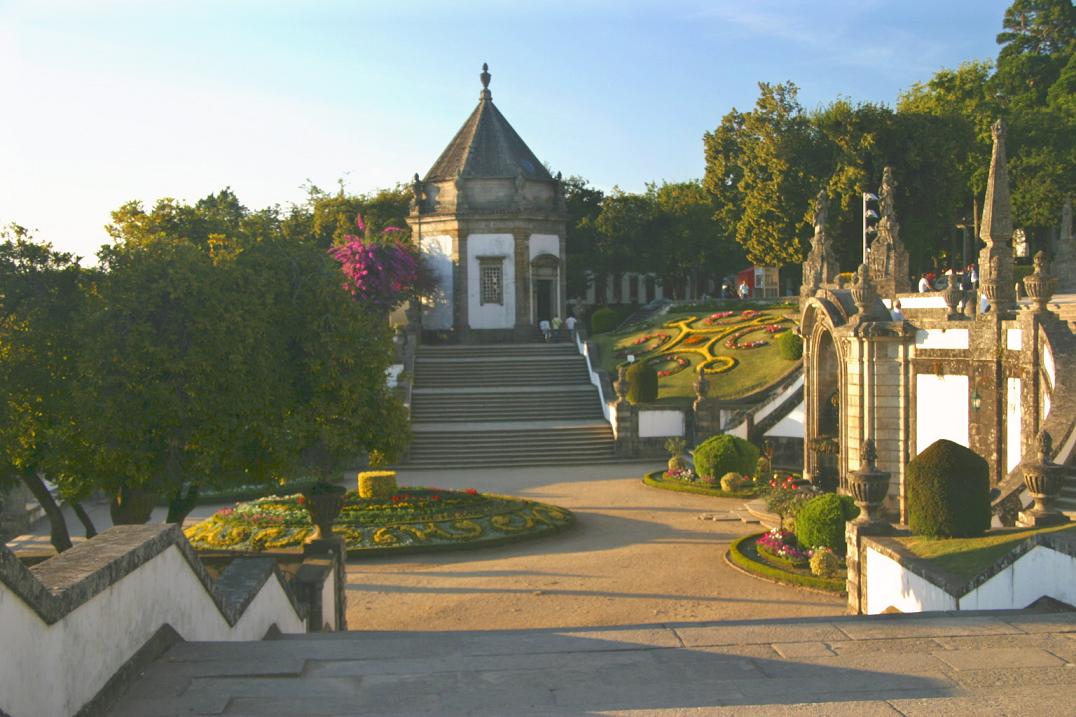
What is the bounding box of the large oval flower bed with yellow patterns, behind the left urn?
[184,488,575,554]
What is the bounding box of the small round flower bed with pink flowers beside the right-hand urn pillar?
[725,529,846,594]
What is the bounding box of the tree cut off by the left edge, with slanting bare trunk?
[0,225,83,552]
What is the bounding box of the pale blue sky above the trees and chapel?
[0,0,1010,264]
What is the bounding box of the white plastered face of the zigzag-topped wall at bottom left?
[0,546,306,717]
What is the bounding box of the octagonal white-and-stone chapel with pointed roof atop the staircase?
[408,65,566,342]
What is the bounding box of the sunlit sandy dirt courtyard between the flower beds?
[348,463,846,631]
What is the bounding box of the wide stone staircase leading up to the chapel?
[407,343,614,468]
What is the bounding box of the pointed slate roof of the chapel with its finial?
[425,65,553,182]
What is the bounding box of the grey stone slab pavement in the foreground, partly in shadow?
[111,611,1076,717]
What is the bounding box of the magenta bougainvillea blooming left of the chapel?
[329,214,420,309]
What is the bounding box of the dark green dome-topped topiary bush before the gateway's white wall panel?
[905,438,990,537]
